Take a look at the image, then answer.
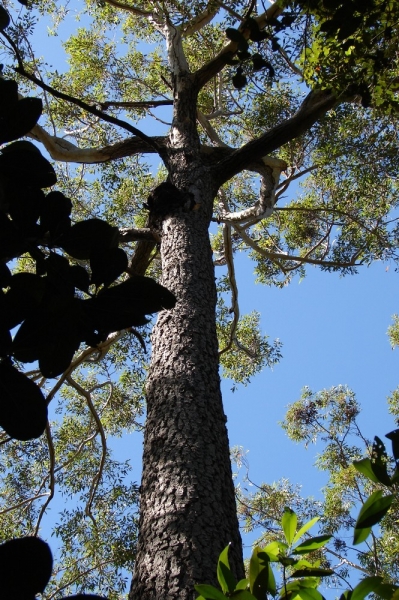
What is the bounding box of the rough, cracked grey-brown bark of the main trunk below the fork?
[131,180,243,600]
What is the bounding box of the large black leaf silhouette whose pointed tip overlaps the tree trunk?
[85,275,176,333]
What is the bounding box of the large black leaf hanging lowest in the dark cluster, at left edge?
[0,361,47,441]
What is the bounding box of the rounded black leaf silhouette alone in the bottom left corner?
[0,537,53,600]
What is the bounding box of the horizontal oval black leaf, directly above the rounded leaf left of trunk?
[59,219,119,260]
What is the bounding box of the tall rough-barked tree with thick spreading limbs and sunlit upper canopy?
[2,0,398,600]
